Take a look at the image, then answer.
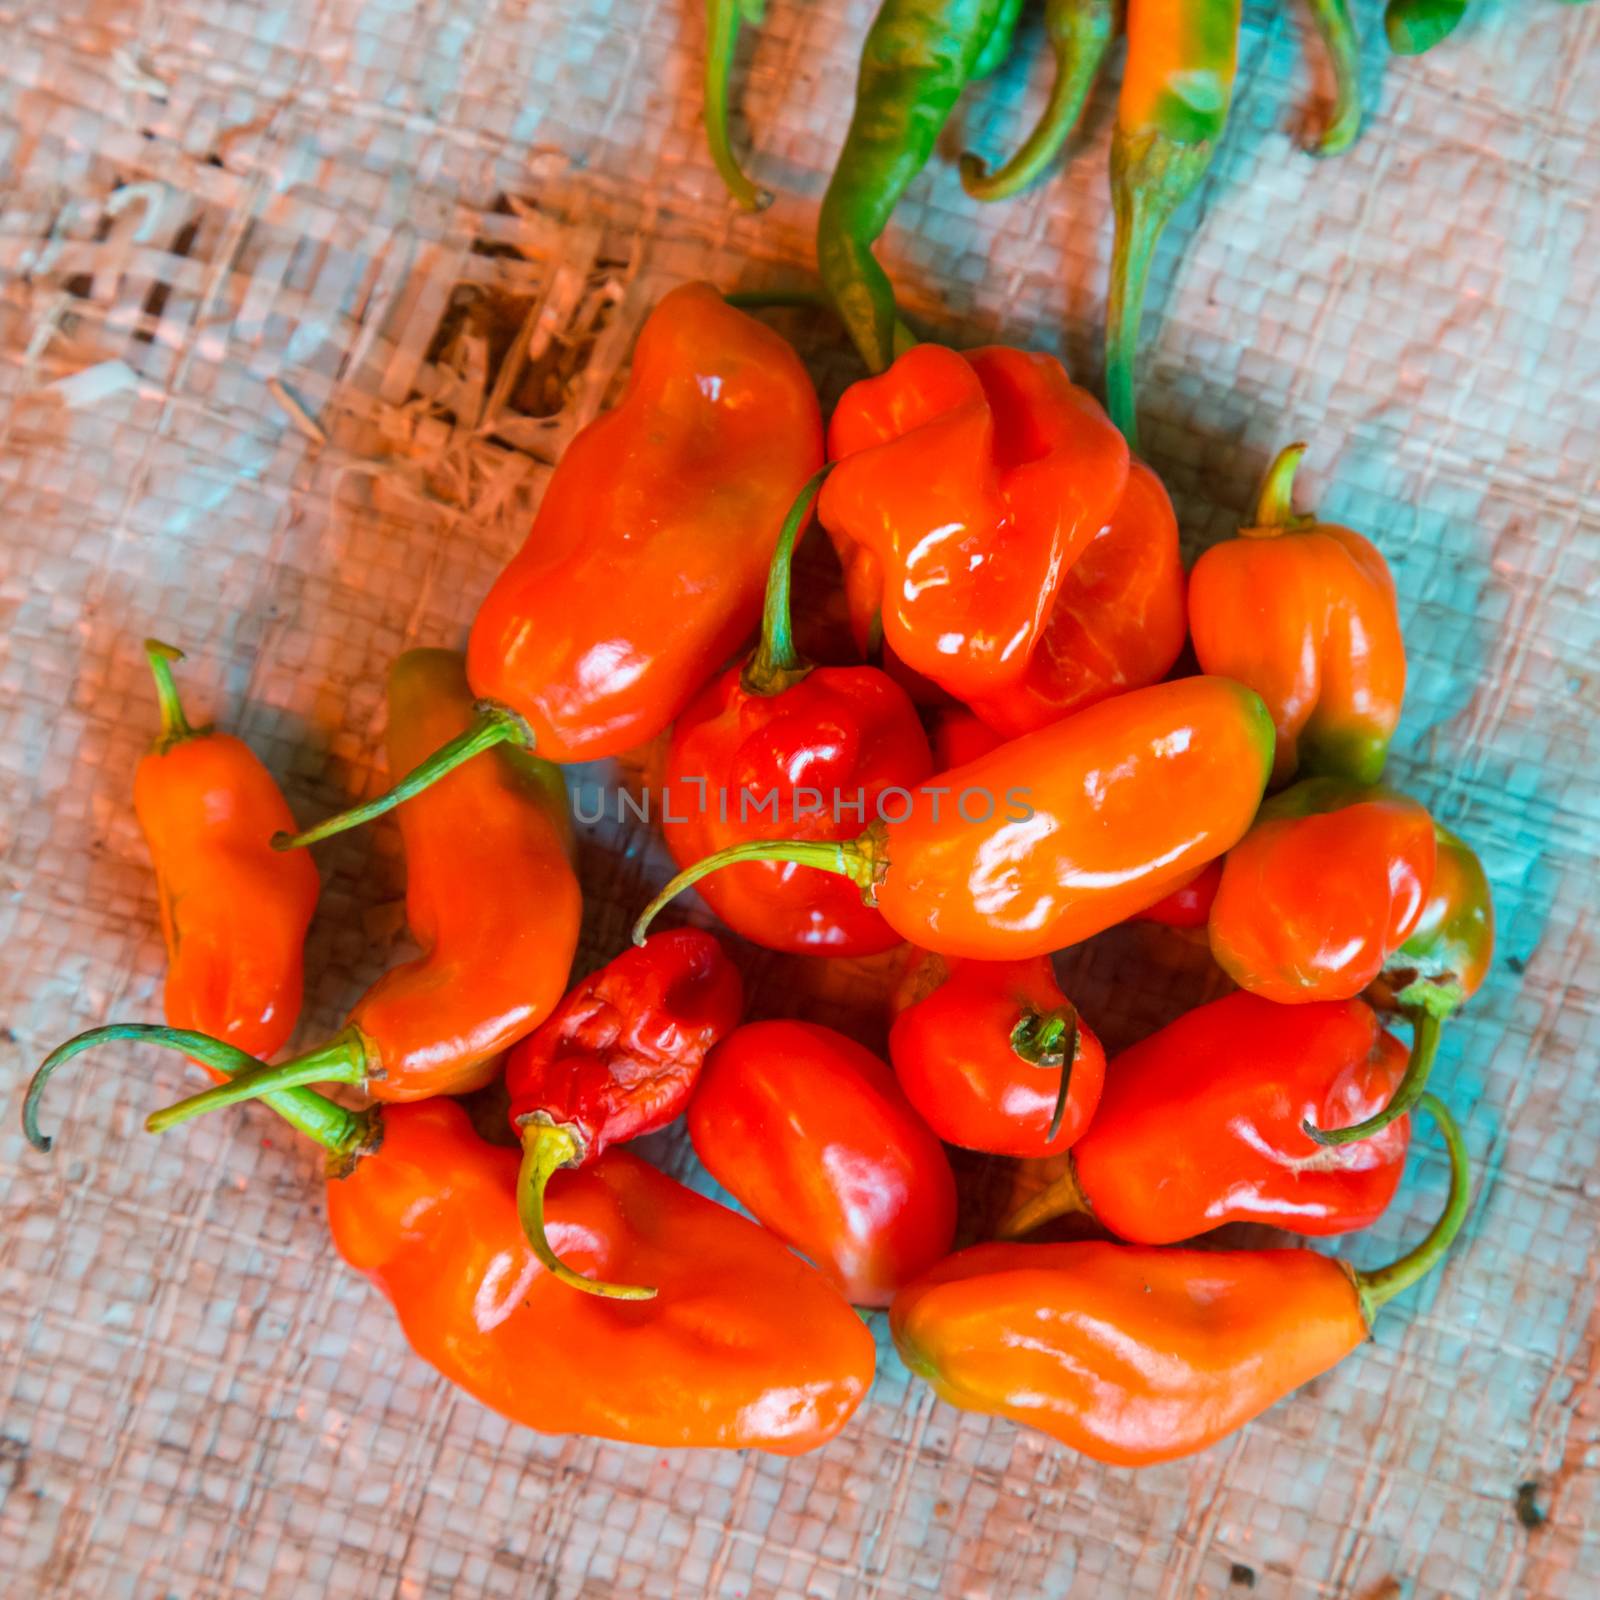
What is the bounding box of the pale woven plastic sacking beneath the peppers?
[0,0,1600,1600]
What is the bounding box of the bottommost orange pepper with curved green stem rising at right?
[890,1094,1470,1467]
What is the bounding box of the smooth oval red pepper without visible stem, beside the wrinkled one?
[688,1022,955,1306]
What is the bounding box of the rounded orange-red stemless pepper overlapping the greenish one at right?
[1210,778,1437,1005]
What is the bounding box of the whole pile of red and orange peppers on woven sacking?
[22,284,1493,1464]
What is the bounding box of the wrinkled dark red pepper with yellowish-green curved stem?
[506,928,744,1299]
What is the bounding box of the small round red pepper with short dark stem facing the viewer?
[890,955,1106,1157]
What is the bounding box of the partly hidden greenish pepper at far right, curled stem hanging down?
[1306,822,1494,1146]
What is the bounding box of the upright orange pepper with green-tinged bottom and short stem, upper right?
[1189,445,1405,786]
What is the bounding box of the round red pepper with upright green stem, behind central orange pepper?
[662,467,933,955]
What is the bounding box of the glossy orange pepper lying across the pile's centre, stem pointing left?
[634,678,1272,960]
